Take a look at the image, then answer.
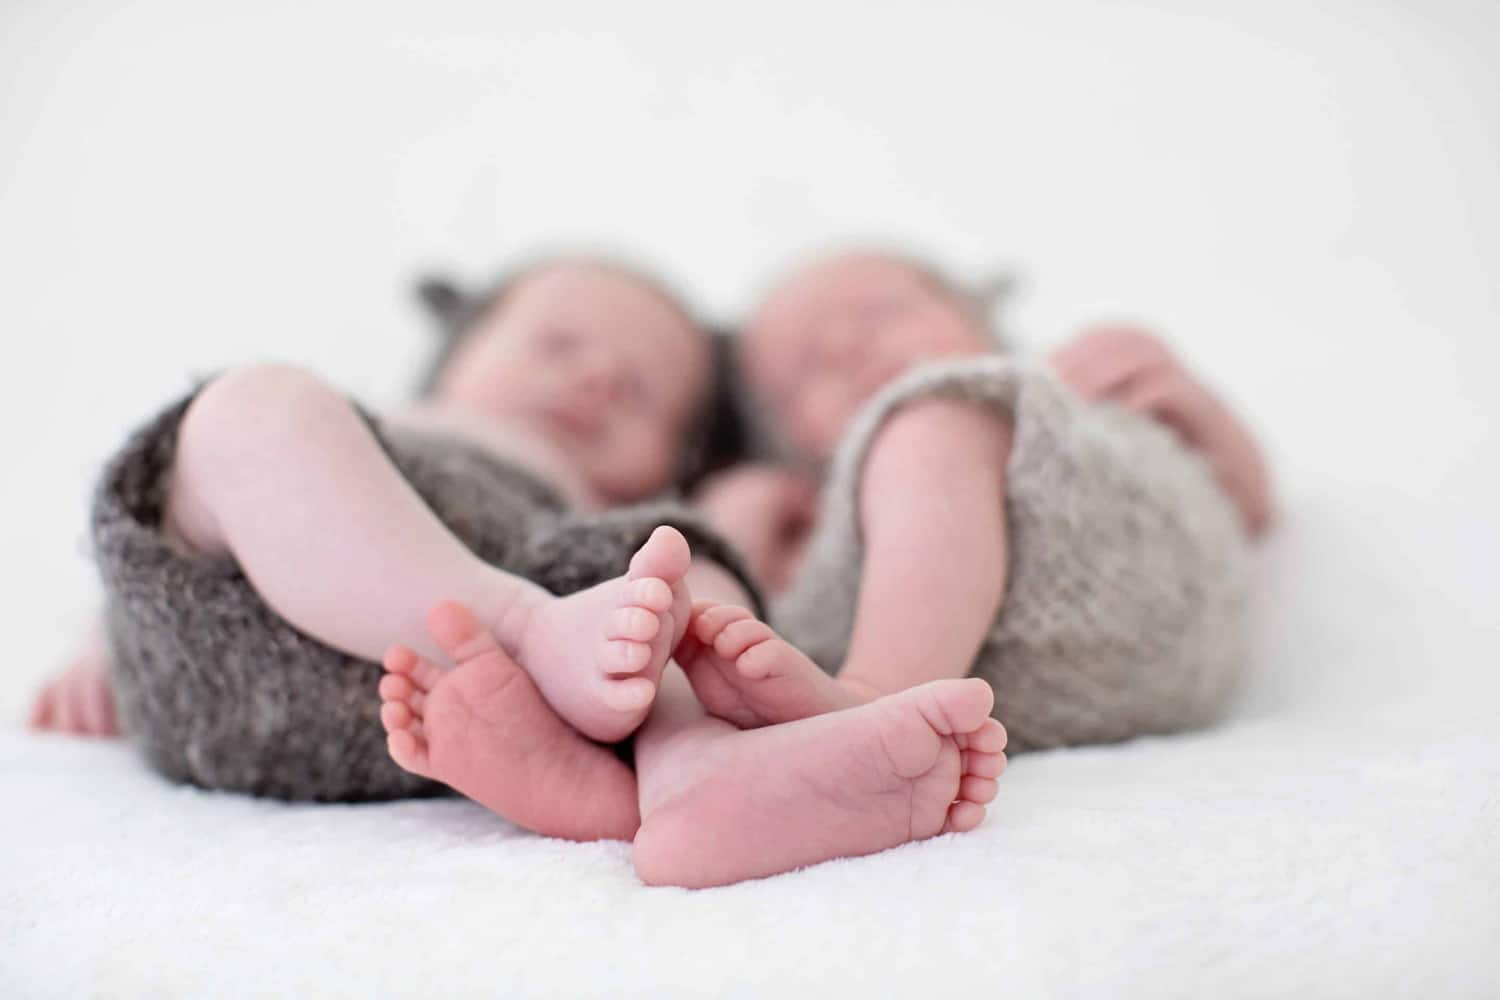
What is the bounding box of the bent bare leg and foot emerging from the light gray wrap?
[678,402,1010,727]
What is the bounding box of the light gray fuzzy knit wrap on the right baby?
[774,357,1248,750]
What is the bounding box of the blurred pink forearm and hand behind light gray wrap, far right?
[1049,327,1272,537]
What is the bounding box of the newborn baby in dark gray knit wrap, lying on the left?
[33,261,746,835]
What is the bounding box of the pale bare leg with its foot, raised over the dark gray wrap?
[165,366,687,739]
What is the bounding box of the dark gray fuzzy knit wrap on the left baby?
[92,394,759,801]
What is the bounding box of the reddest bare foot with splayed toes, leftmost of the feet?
[380,601,639,840]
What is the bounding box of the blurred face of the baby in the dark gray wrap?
[437,262,711,502]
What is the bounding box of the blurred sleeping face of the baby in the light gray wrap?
[743,255,989,459]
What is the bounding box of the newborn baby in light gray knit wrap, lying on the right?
[678,253,1271,750]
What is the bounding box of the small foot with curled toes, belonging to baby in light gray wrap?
[677,601,869,729]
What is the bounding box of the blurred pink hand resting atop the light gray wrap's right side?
[1047,325,1208,445]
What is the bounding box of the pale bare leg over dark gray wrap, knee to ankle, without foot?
[165,366,540,661]
